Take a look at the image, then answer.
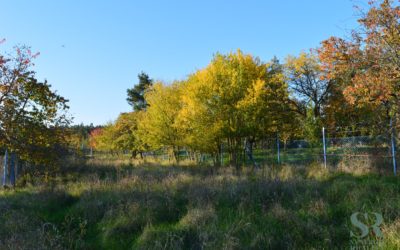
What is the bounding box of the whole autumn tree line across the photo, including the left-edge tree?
[0,0,400,172]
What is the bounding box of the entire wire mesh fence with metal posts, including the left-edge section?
[0,127,399,185]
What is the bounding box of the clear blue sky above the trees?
[0,0,366,124]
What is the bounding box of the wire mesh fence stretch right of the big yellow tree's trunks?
[245,135,393,172]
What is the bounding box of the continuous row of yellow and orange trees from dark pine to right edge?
[90,0,400,168]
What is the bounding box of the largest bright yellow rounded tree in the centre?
[180,50,290,165]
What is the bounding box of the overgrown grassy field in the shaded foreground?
[0,160,400,249]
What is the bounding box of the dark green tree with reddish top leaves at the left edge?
[0,47,69,164]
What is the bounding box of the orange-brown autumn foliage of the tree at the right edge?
[319,0,400,111]
